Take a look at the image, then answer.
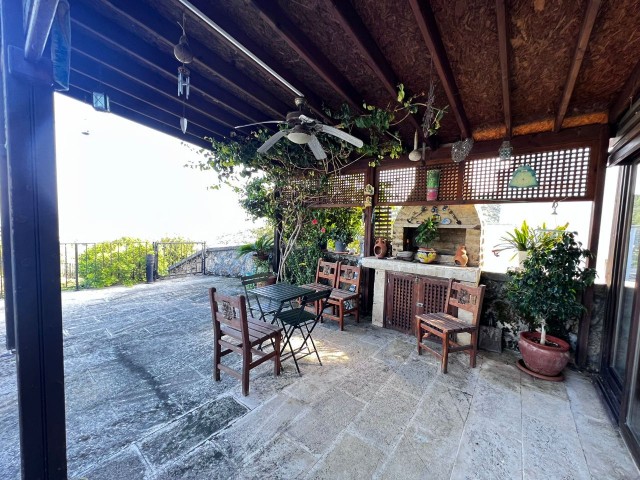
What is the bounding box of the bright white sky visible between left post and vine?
[50,94,261,246]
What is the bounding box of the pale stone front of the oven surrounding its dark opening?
[391,205,482,267]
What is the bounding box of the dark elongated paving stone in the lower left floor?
[139,397,246,467]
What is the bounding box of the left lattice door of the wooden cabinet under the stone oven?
[384,272,419,334]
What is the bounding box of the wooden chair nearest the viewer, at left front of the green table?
[209,288,282,396]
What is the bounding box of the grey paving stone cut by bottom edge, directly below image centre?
[303,433,384,480]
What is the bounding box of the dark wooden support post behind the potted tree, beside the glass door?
[576,124,609,368]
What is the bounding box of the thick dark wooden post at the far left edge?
[0,0,67,479]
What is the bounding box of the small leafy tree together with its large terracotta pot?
[506,230,596,380]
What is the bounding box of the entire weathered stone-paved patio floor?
[0,277,640,480]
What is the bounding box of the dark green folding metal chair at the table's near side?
[276,290,331,374]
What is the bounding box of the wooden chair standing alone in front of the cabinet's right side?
[416,280,485,373]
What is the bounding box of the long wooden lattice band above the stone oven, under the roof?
[377,146,595,205]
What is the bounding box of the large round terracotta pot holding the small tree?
[518,332,569,377]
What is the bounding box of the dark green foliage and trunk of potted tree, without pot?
[505,231,596,345]
